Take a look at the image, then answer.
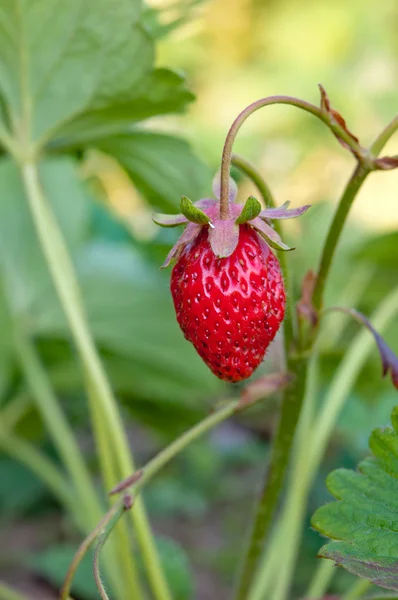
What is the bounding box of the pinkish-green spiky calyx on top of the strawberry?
[152,176,310,268]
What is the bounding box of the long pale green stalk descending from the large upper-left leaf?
[21,161,171,600]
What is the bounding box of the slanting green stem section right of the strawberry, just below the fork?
[312,164,371,310]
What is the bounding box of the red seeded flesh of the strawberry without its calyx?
[171,224,285,382]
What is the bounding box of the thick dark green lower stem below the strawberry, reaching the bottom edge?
[236,356,307,600]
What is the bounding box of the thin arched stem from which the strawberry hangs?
[220,96,362,219]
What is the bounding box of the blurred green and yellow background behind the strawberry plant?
[0,0,398,600]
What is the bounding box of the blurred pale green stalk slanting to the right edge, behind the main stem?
[255,288,398,600]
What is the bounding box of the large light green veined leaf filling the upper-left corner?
[0,0,153,140]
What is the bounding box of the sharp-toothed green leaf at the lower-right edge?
[312,407,398,591]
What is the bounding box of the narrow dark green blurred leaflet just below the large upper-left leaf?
[50,68,194,149]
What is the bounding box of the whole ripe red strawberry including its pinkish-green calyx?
[154,177,309,382]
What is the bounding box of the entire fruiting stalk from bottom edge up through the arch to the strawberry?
[236,110,398,600]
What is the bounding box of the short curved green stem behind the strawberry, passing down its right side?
[231,154,297,356]
